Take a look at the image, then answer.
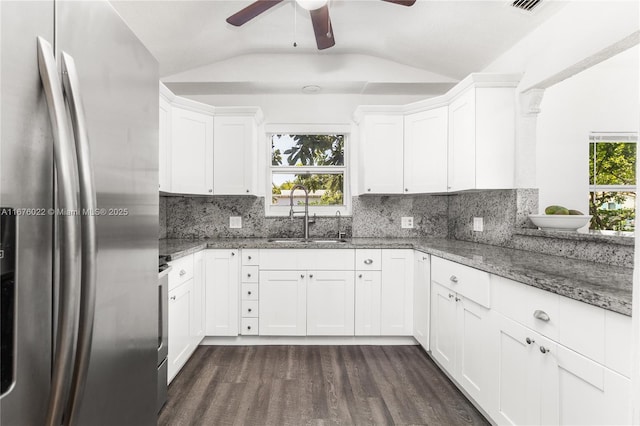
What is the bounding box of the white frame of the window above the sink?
[264,124,352,217]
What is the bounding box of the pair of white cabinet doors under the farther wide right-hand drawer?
[430,282,493,406]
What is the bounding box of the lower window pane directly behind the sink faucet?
[271,173,344,206]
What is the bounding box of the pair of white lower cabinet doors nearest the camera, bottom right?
[489,311,631,425]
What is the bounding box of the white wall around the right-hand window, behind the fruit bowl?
[536,48,640,213]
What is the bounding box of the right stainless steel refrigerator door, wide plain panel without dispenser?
[56,1,159,425]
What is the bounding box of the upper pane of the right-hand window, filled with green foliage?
[589,142,636,185]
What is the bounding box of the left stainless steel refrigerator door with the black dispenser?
[0,1,54,425]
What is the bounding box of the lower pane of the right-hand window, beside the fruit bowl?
[589,191,636,231]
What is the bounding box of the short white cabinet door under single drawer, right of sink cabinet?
[355,271,382,336]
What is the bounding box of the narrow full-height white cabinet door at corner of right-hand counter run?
[413,251,431,351]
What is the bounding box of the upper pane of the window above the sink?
[271,135,344,166]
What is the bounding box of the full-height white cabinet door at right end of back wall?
[380,249,413,336]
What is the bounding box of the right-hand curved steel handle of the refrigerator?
[61,52,98,425]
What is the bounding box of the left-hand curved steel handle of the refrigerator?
[37,37,80,426]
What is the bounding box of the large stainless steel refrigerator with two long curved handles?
[0,0,159,426]
